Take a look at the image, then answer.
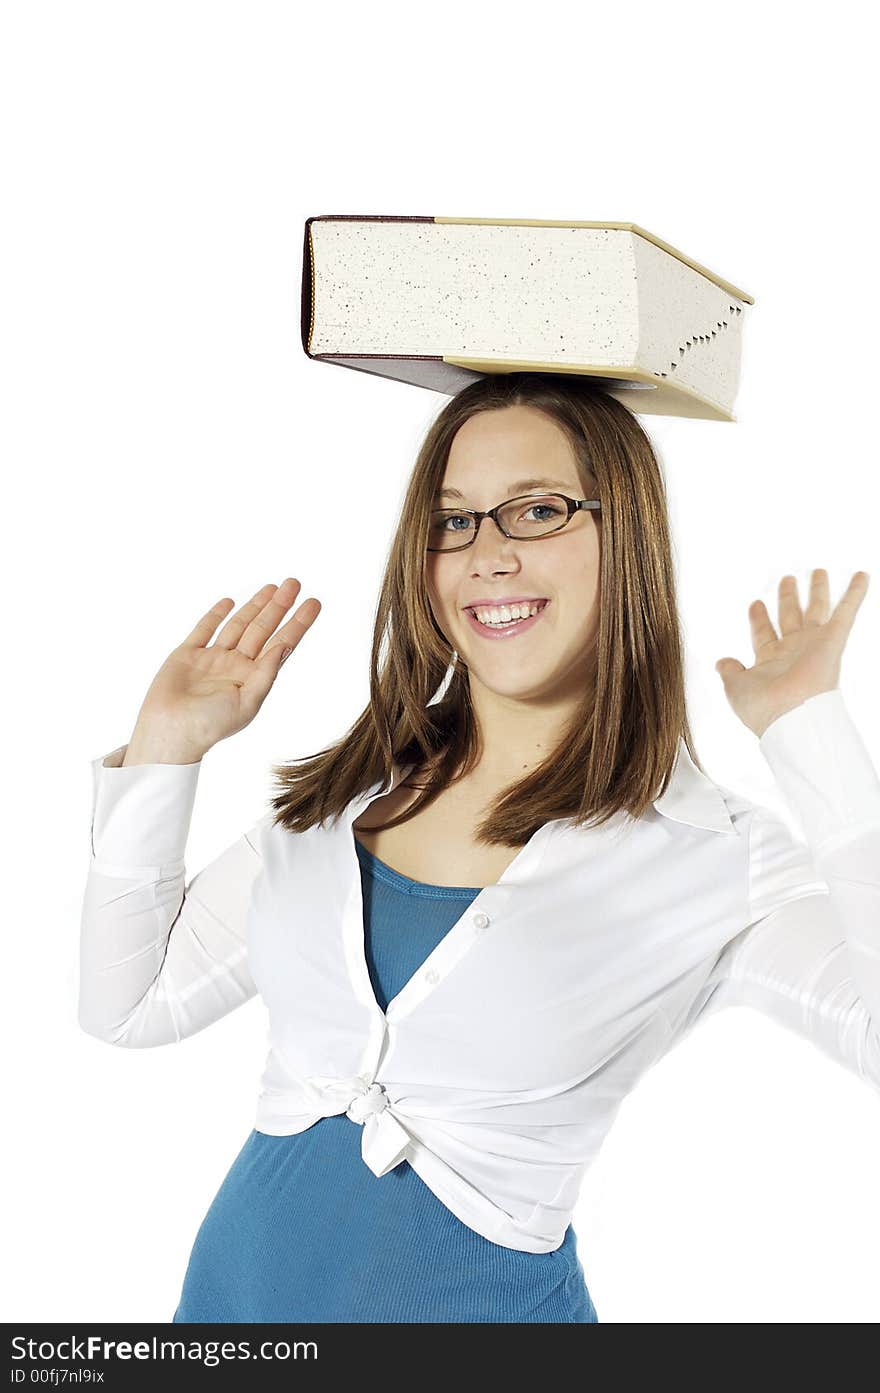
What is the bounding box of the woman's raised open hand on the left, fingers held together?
[124,577,320,763]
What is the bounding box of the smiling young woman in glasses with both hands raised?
[79,373,880,1322]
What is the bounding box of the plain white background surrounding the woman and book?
[0,0,880,1322]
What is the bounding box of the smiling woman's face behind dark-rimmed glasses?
[426,405,602,703]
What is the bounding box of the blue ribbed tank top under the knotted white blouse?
[173,833,599,1323]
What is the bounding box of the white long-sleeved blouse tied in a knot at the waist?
[79,690,880,1252]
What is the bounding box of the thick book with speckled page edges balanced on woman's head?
[302,213,755,421]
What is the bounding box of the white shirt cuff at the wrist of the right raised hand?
[760,687,880,853]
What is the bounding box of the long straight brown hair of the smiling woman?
[264,372,702,847]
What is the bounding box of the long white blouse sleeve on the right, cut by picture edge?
[665,688,880,1089]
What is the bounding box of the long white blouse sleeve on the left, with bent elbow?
[78,745,272,1049]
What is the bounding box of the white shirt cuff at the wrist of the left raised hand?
[91,744,202,876]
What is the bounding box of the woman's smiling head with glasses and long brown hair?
[273,372,699,848]
